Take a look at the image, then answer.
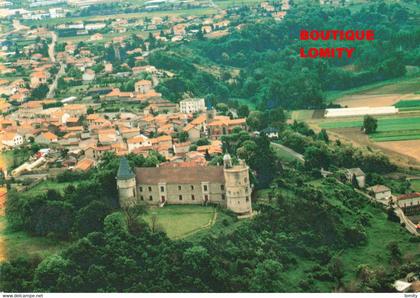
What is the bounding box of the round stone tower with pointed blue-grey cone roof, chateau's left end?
[116,157,137,208]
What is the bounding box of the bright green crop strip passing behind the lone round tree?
[320,117,420,142]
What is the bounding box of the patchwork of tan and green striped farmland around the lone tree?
[304,76,420,168]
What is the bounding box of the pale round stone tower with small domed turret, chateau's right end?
[223,154,252,214]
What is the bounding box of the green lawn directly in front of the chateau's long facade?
[144,205,216,239]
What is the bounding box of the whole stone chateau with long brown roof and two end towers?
[116,154,252,214]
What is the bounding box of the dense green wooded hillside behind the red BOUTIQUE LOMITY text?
[150,1,420,110]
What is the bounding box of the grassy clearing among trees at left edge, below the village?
[0,216,69,261]
